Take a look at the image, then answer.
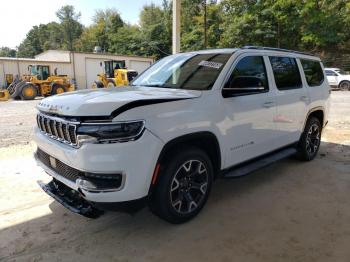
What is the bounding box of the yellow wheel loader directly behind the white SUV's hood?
[92,60,138,88]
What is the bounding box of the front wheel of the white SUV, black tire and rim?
[150,147,214,224]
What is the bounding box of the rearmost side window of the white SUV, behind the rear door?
[300,59,324,86]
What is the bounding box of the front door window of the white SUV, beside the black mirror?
[225,56,269,95]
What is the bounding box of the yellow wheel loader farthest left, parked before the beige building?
[7,65,75,100]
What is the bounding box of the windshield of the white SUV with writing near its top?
[132,53,232,90]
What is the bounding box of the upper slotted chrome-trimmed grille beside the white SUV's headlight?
[36,113,77,146]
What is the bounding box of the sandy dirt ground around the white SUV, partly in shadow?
[0,92,350,262]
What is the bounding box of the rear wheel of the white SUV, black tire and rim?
[297,117,322,161]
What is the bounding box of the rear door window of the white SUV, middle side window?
[270,56,302,90]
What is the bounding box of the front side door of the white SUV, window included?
[218,54,276,167]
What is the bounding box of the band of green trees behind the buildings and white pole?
[13,0,350,59]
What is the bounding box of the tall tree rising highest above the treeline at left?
[56,5,83,51]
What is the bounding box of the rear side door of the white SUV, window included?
[269,56,310,147]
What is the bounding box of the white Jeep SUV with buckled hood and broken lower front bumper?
[35,47,330,223]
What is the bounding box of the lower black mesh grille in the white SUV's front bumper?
[36,148,85,182]
